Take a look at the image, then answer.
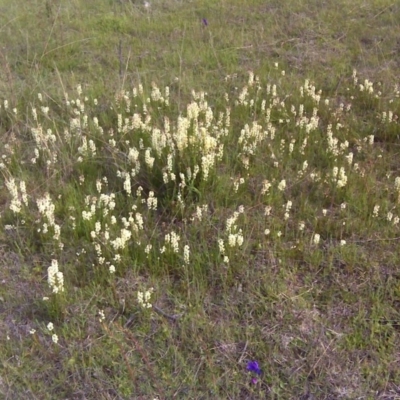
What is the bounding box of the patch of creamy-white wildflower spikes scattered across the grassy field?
[2,71,400,340]
